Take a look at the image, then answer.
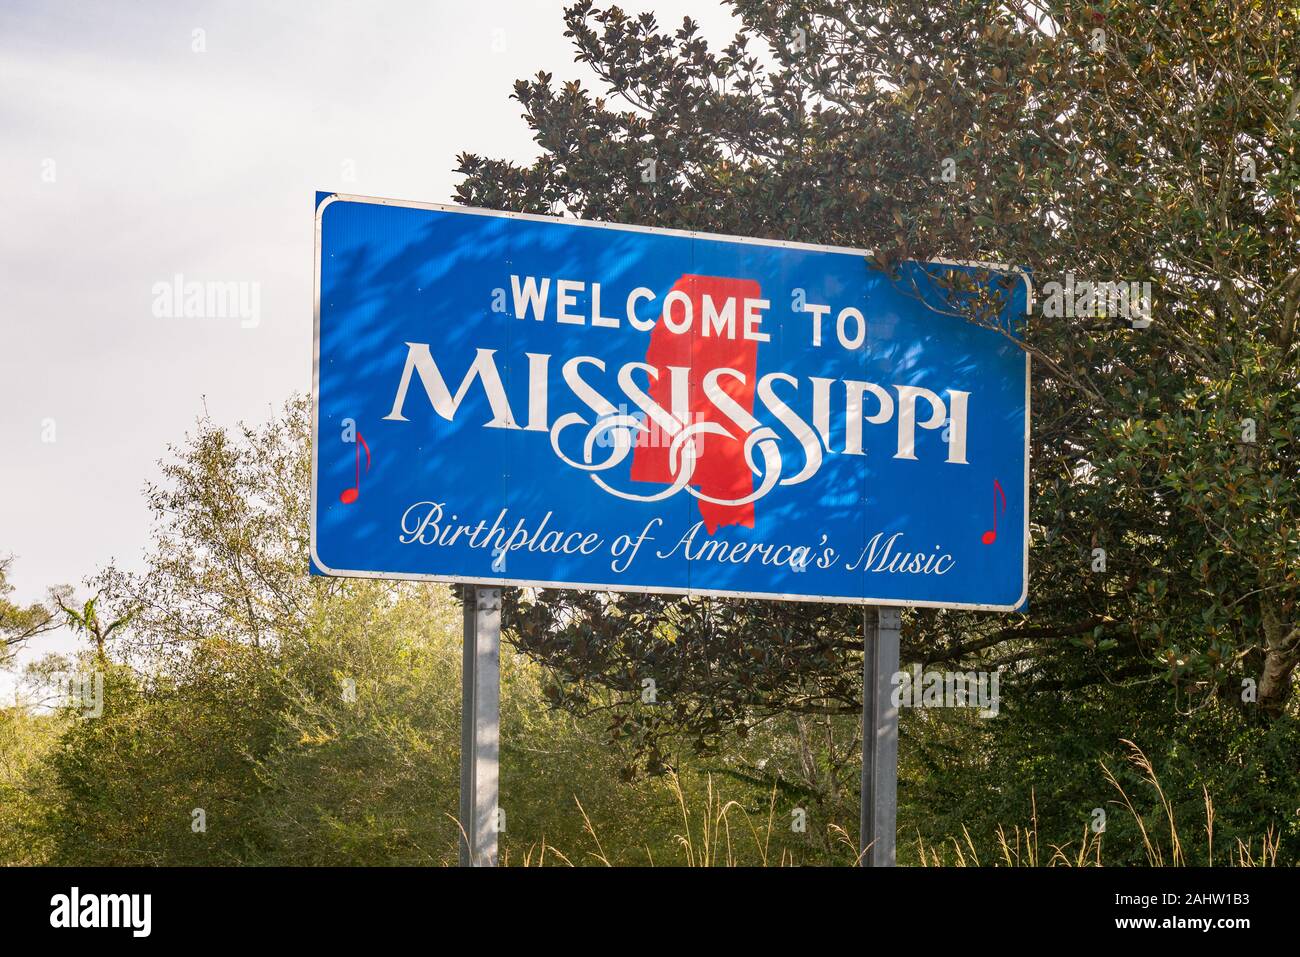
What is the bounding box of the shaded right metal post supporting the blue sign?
[858,609,901,867]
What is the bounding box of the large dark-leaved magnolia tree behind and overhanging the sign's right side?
[456,0,1300,768]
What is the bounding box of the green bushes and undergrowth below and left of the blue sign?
[0,400,1300,865]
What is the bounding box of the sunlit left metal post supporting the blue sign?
[460,585,501,867]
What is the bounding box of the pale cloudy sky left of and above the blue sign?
[0,0,735,702]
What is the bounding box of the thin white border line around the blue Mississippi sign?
[309,192,1034,611]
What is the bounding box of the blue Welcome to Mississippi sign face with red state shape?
[311,194,1030,611]
